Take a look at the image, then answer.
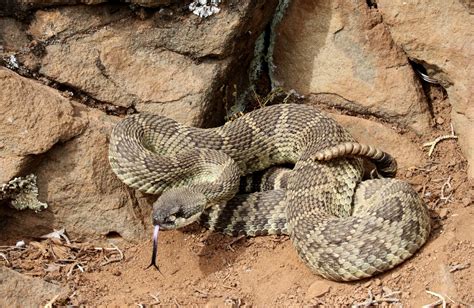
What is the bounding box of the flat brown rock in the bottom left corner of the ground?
[0,267,67,307]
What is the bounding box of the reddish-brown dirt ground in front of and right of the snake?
[0,95,474,307]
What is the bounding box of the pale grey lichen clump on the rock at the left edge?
[0,174,48,212]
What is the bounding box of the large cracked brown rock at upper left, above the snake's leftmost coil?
[19,0,276,126]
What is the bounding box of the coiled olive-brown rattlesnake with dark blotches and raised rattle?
[109,104,430,281]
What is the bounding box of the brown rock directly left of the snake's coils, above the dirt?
[0,104,151,241]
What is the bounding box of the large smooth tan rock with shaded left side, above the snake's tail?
[274,0,429,134]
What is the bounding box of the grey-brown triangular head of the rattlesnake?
[153,187,207,230]
